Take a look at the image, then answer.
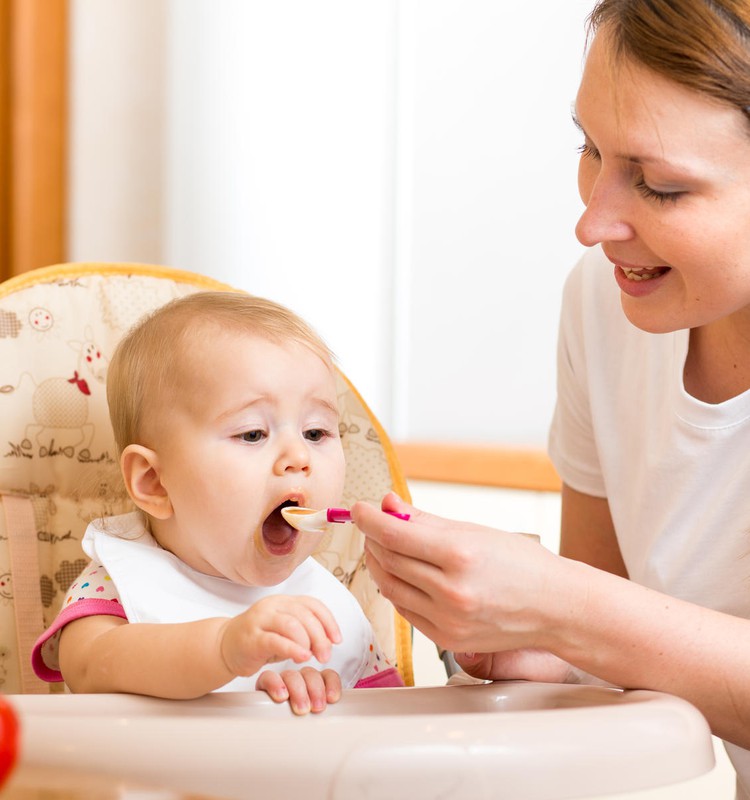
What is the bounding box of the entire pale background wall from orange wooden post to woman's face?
[70,0,591,444]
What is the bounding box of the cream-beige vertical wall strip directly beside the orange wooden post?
[68,0,167,263]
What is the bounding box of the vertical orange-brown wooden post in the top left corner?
[0,0,68,280]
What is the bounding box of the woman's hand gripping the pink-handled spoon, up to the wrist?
[352,494,577,656]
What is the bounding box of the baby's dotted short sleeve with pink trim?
[31,561,127,683]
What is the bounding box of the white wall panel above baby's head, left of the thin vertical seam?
[166,0,395,432]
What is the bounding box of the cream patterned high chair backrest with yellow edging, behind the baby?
[0,263,413,693]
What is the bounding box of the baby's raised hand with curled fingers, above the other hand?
[220,595,341,676]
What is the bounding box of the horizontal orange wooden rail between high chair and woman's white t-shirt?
[394,442,562,492]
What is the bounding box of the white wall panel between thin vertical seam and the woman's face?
[395,0,592,444]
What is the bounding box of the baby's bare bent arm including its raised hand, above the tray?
[60,595,341,698]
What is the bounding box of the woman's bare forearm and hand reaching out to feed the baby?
[352,495,750,747]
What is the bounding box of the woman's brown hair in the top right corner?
[588,0,750,118]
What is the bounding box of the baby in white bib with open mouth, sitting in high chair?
[32,292,402,714]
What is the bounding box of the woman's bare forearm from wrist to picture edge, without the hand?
[543,559,750,748]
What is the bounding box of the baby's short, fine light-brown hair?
[107,291,333,453]
